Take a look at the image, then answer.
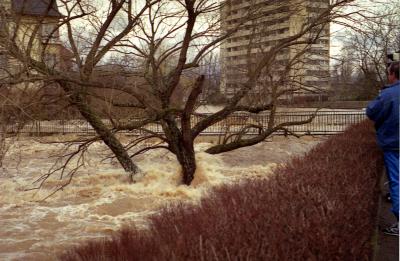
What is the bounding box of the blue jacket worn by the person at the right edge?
[366,81,400,150]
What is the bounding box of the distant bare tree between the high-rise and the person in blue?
[336,1,400,100]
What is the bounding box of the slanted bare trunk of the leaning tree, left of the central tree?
[61,83,139,182]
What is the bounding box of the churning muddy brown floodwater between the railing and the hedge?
[0,137,321,260]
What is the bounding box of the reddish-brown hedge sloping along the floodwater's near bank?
[60,122,382,261]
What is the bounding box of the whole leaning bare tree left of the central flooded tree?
[1,0,158,181]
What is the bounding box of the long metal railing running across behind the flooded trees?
[6,111,366,135]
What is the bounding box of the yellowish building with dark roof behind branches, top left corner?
[0,0,72,77]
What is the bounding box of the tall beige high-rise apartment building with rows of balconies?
[221,0,330,99]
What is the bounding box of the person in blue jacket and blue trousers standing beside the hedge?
[366,61,400,236]
